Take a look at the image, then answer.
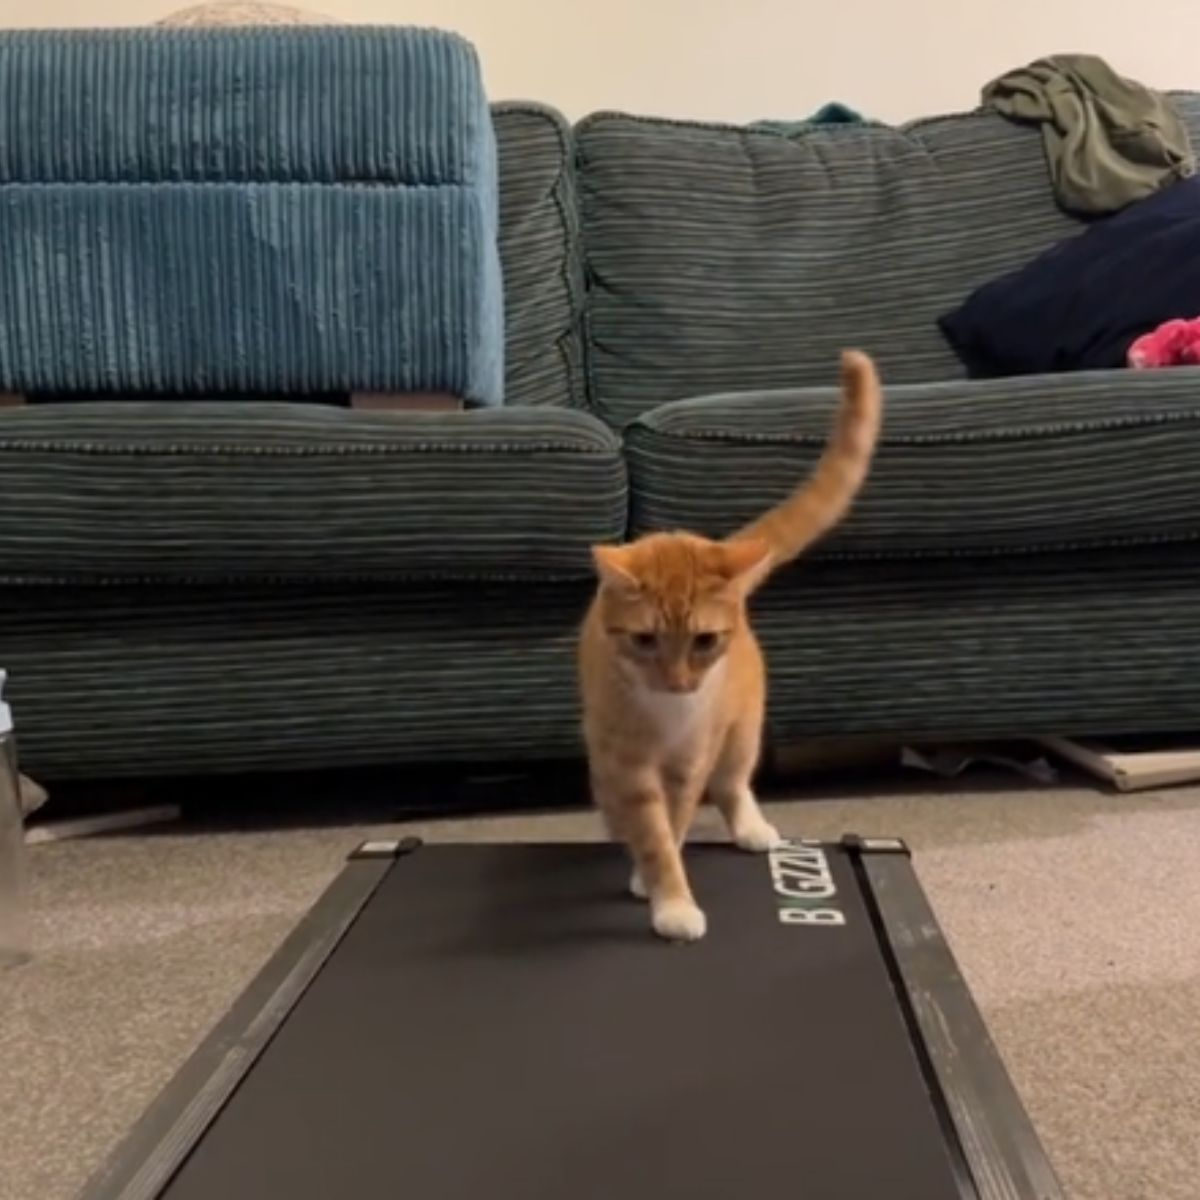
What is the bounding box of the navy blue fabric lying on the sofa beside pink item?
[938,178,1200,378]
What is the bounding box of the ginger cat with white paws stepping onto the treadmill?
[578,350,883,941]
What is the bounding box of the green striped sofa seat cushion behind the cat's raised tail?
[628,368,1200,558]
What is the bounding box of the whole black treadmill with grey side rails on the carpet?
[82,836,1063,1200]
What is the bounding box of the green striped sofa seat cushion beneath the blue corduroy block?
[0,401,626,583]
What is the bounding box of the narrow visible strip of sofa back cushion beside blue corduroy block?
[492,102,587,408]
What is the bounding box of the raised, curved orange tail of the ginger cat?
[730,350,883,566]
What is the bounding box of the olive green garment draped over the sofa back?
[983,54,1195,214]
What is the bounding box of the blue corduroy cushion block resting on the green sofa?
[0,26,504,404]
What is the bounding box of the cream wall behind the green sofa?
[0,0,1200,120]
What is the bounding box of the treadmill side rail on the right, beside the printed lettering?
[859,851,1066,1200]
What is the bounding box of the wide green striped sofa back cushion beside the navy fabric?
[576,96,1200,425]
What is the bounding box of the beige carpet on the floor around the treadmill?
[0,788,1200,1200]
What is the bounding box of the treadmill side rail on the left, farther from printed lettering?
[78,842,398,1200]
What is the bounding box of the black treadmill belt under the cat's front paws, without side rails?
[164,845,962,1200]
